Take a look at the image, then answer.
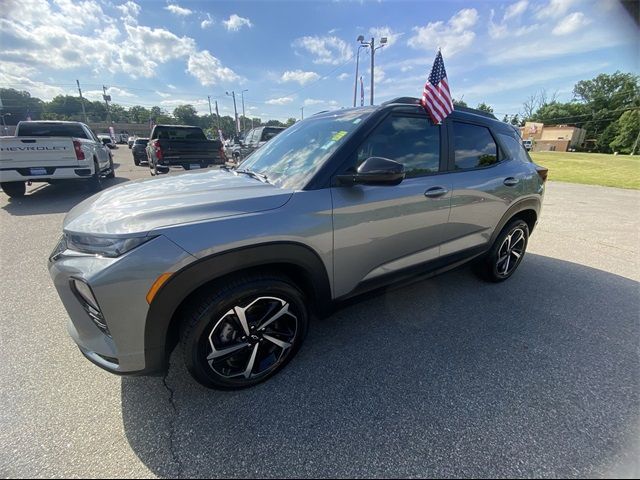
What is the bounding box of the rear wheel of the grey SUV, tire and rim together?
[476,219,529,282]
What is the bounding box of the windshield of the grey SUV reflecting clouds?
[239,109,372,188]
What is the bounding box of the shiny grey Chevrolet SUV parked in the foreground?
[49,98,547,389]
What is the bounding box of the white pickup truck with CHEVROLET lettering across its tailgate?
[0,121,115,197]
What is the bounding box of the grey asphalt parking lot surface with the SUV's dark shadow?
[0,146,640,478]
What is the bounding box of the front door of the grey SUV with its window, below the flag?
[331,111,451,297]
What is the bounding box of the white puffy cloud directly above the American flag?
[407,8,478,57]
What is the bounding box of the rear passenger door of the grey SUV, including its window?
[442,120,522,255]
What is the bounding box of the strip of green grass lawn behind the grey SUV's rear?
[529,152,640,190]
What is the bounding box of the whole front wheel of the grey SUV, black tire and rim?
[180,274,308,390]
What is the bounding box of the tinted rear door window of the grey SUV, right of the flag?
[453,122,498,170]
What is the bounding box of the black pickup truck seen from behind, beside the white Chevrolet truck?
[147,125,226,175]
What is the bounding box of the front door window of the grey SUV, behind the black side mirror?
[356,115,440,178]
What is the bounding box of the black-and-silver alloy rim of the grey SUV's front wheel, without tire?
[206,296,298,381]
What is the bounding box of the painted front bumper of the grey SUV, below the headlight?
[49,236,194,375]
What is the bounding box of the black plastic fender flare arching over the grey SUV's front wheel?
[144,242,332,371]
